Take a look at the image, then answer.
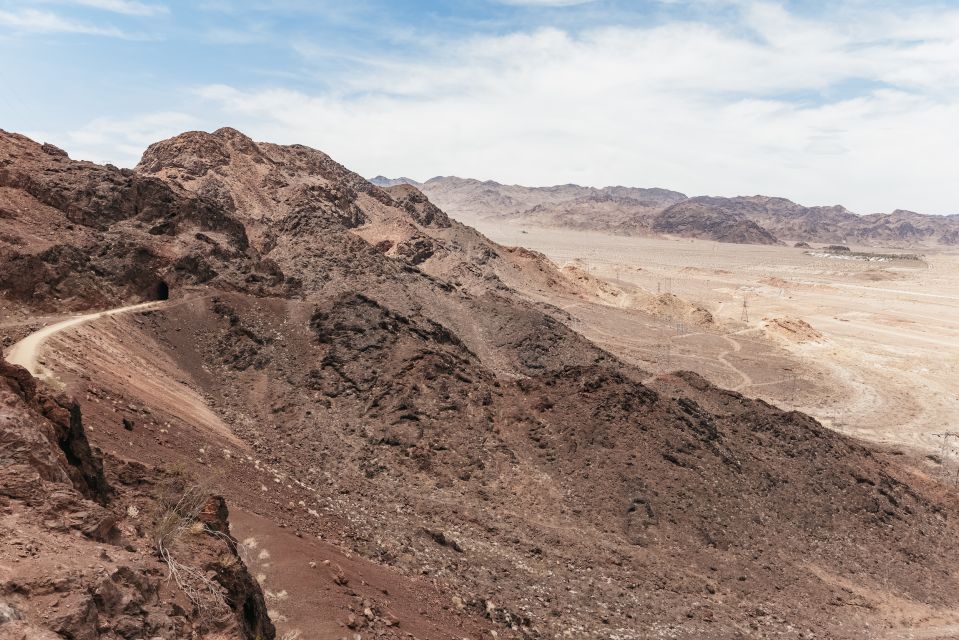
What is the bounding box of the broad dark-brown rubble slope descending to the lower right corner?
[142,295,959,638]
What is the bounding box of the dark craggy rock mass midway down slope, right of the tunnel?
[307,294,492,456]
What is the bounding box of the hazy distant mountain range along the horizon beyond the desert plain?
[371,176,959,247]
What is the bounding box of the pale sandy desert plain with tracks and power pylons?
[477,222,959,466]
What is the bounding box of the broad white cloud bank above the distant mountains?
[62,2,959,213]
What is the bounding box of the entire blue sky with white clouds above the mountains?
[0,0,959,214]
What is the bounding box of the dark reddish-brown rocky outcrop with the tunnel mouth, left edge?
[0,131,278,309]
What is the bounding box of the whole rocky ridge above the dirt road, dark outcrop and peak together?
[0,129,563,316]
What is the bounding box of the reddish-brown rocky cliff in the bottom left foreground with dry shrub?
[0,360,274,640]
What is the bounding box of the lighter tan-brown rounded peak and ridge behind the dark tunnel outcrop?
[136,128,576,304]
